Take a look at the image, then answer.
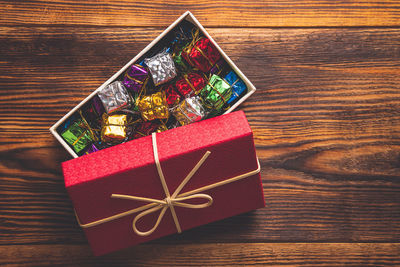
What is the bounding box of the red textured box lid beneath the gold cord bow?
[62,111,265,255]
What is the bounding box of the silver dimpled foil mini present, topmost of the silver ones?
[144,50,176,86]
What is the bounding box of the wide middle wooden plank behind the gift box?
[0,27,400,246]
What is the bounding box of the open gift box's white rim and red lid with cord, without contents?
[50,12,265,255]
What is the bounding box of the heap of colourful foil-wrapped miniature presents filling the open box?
[57,21,247,156]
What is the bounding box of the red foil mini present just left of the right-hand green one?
[176,72,206,97]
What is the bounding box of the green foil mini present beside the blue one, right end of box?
[200,74,232,110]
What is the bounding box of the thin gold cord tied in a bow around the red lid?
[75,133,260,236]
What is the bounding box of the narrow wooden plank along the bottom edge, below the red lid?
[0,243,400,266]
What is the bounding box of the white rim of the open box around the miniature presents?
[50,11,256,158]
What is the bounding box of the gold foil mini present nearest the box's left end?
[101,114,128,144]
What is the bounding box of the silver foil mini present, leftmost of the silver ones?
[97,81,131,114]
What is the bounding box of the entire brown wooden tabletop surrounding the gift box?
[0,0,400,266]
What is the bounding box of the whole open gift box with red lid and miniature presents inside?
[50,12,265,255]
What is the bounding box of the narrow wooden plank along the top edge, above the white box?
[0,0,400,27]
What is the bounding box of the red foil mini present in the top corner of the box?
[182,37,221,72]
